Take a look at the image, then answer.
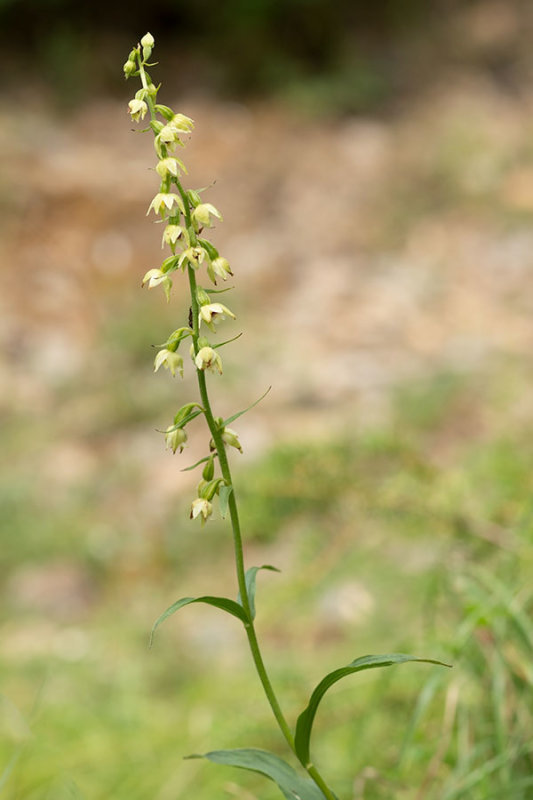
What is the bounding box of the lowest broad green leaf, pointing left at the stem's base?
[188,747,324,800]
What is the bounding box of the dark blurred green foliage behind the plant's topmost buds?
[0,0,450,111]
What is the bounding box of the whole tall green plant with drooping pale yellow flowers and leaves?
[124,33,441,800]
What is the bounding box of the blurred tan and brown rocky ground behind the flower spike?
[0,66,533,444]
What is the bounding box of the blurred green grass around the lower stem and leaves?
[0,364,533,800]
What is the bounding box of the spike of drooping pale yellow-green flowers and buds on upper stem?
[124,33,242,525]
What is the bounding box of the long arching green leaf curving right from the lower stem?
[294,653,450,766]
